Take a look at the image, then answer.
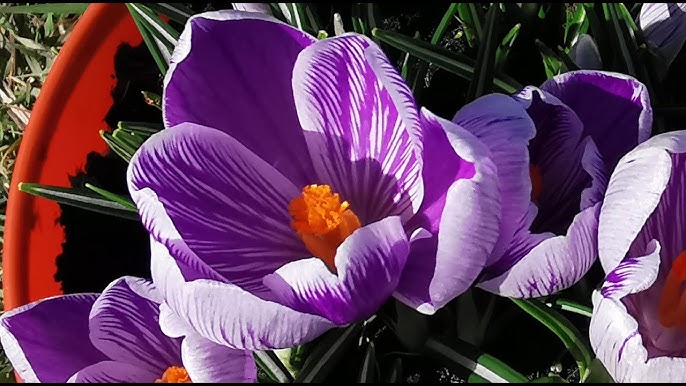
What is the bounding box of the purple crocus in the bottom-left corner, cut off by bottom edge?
[0,277,257,383]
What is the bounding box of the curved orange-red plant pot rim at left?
[2,3,142,310]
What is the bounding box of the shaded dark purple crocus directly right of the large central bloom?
[454,71,652,298]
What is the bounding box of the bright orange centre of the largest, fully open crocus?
[288,184,361,272]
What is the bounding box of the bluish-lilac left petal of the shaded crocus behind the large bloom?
[453,94,536,263]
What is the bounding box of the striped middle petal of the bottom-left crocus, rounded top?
[90,277,181,375]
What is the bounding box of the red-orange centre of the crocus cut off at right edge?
[657,251,686,330]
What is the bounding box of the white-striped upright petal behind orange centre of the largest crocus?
[293,34,423,224]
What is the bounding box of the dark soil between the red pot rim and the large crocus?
[55,44,162,293]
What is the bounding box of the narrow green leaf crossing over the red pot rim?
[18,182,140,221]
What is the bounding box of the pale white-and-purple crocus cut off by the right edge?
[590,131,686,383]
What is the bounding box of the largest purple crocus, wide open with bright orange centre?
[128,11,518,349]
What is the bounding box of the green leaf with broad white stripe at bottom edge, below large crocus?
[425,338,528,383]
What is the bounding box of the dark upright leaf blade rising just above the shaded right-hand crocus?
[467,3,500,102]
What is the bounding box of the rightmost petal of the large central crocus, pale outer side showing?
[394,109,500,314]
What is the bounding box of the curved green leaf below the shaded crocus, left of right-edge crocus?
[510,298,593,379]
